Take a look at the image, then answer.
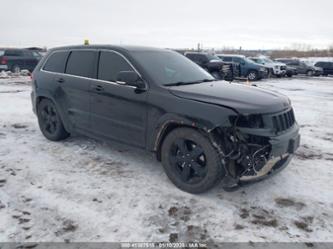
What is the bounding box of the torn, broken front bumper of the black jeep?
[219,122,300,190]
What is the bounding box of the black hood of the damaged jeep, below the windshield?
[169,81,290,114]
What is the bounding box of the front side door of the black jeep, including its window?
[91,51,147,147]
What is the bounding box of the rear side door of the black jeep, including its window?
[62,50,98,131]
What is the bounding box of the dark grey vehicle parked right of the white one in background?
[276,58,323,76]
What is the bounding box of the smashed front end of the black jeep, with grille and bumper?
[214,107,300,189]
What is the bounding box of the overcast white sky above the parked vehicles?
[0,0,333,49]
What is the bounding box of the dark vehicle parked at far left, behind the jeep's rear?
[0,48,42,73]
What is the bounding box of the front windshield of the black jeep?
[131,50,214,85]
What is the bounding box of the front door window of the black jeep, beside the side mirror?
[98,52,133,82]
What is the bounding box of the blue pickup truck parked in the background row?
[216,54,268,81]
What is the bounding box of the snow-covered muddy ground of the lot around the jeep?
[0,77,333,242]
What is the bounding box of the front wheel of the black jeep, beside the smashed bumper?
[161,128,224,194]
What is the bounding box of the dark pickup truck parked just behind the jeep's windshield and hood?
[184,52,238,80]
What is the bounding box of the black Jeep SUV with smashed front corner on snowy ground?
[31,45,299,193]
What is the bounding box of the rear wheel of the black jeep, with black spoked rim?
[37,99,69,141]
